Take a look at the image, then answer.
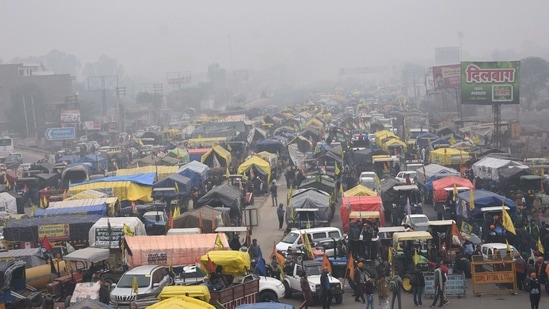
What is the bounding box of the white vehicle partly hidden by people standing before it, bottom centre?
[284,261,344,304]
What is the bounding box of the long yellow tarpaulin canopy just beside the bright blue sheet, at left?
[68,181,152,202]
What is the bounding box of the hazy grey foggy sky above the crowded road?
[0,0,549,80]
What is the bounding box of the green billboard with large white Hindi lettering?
[461,61,520,105]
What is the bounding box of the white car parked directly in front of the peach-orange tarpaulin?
[110,265,172,309]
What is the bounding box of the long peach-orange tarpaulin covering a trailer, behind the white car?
[125,233,229,268]
